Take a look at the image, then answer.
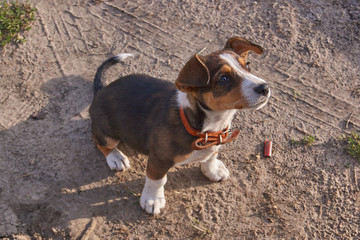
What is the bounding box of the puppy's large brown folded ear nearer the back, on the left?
[175,54,210,93]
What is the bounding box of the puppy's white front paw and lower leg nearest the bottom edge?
[140,177,166,215]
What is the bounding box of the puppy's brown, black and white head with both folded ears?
[175,37,270,111]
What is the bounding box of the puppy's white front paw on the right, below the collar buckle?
[201,159,230,182]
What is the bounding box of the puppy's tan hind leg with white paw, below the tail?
[96,137,130,171]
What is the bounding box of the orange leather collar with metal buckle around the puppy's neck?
[180,107,240,150]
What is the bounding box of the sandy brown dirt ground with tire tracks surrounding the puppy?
[0,0,360,239]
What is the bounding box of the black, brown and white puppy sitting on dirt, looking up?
[90,37,270,215]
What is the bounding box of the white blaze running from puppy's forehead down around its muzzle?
[220,53,270,109]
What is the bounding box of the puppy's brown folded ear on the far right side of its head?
[225,37,264,61]
